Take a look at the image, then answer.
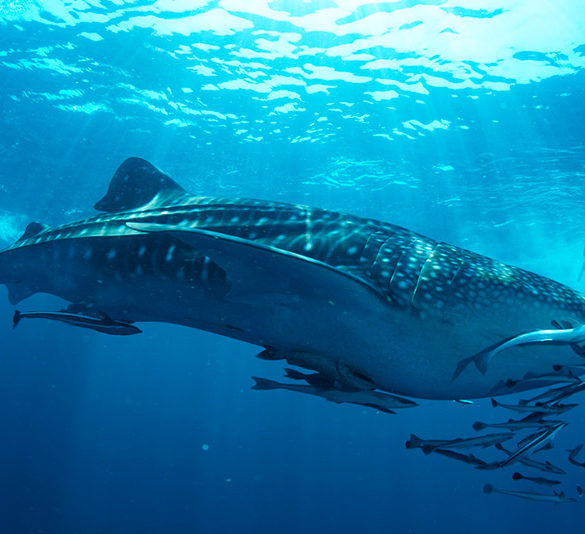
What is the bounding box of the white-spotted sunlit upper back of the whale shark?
[7,197,585,320]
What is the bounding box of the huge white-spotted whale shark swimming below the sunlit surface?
[0,158,585,402]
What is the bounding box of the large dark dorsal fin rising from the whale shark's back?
[94,158,186,213]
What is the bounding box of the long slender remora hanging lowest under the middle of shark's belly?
[252,376,417,413]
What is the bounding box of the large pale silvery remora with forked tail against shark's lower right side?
[451,321,585,381]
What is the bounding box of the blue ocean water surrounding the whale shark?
[0,0,585,534]
